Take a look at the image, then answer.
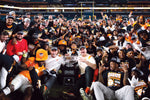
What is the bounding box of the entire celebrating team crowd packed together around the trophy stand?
[0,11,150,100]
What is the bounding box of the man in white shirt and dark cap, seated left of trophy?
[41,47,64,99]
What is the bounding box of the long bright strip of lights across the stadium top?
[0,5,150,10]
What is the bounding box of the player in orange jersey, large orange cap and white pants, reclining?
[0,49,48,100]
